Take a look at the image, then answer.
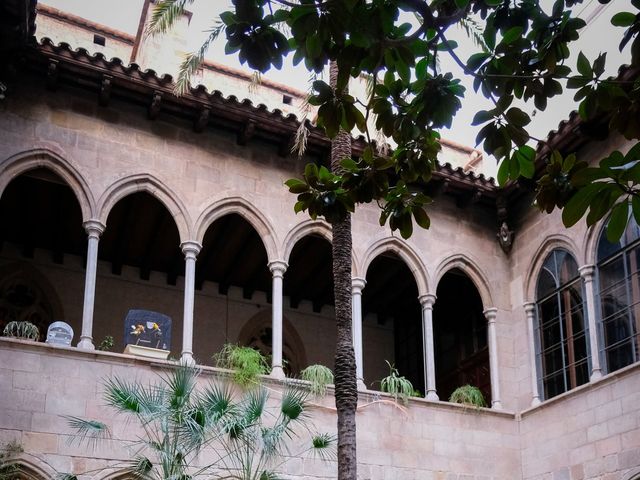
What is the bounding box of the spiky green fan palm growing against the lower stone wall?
[64,365,334,480]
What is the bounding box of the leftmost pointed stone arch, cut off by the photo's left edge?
[0,148,96,221]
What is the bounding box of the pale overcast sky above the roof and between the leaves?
[41,0,634,175]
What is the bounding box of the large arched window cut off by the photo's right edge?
[598,217,640,372]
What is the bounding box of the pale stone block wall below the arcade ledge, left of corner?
[0,338,520,480]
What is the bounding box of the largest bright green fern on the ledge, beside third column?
[213,343,270,388]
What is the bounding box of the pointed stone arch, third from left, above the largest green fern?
[194,197,279,262]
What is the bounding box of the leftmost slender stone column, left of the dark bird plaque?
[78,220,105,350]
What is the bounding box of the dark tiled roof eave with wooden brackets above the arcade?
[28,38,498,199]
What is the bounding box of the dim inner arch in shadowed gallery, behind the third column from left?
[238,310,307,372]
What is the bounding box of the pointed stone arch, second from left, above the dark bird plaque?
[97,173,191,242]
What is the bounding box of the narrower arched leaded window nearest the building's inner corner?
[536,249,589,399]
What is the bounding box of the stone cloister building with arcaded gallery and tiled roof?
[0,0,640,480]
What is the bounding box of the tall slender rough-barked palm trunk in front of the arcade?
[329,62,358,480]
